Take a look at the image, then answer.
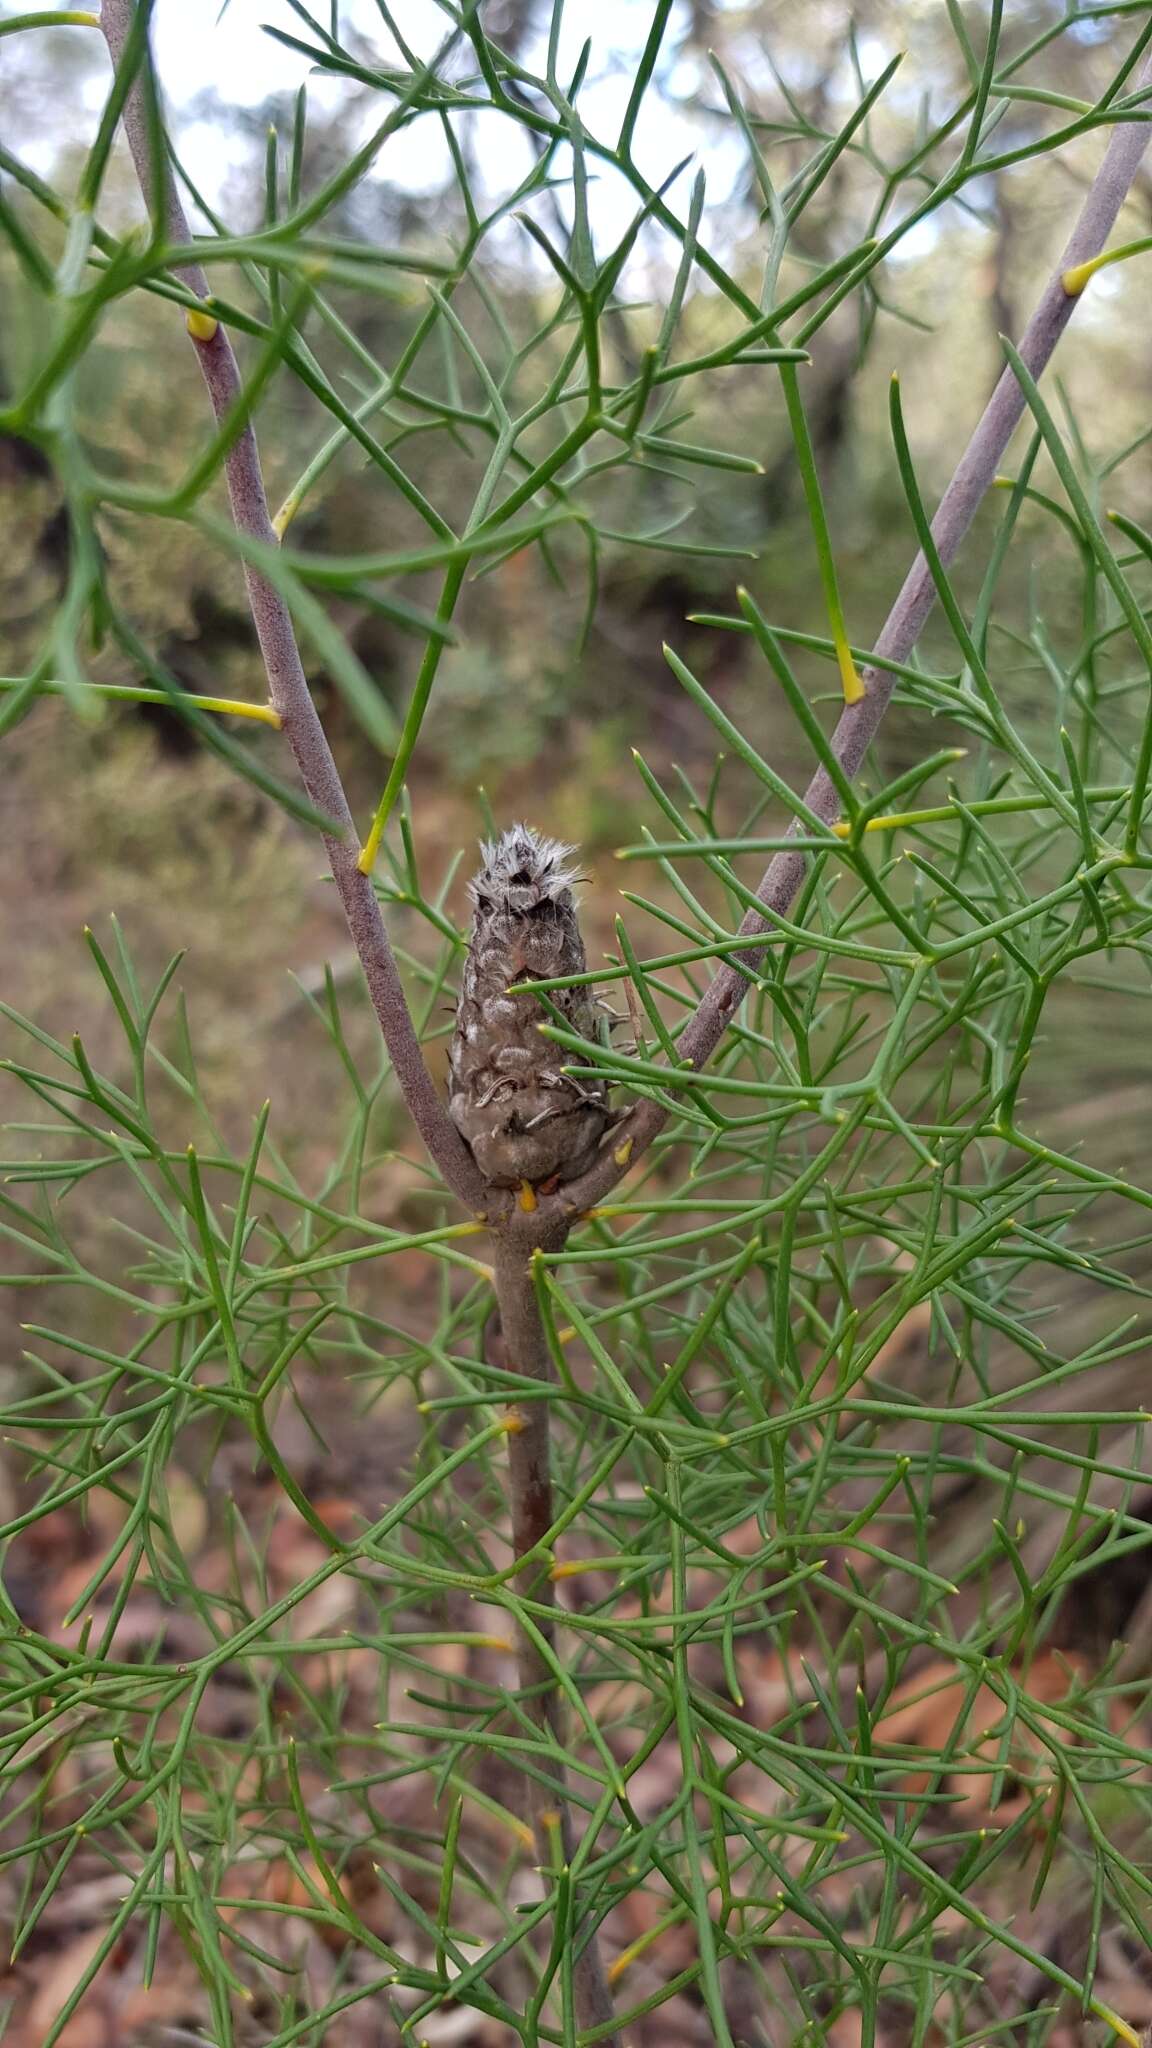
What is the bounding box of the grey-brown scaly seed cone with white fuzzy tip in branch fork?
[449,825,611,1188]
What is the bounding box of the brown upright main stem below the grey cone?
[494,1233,617,2048]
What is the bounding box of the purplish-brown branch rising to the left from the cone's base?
[100,0,486,1210]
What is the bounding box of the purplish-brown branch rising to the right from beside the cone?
[539,59,1152,1227]
